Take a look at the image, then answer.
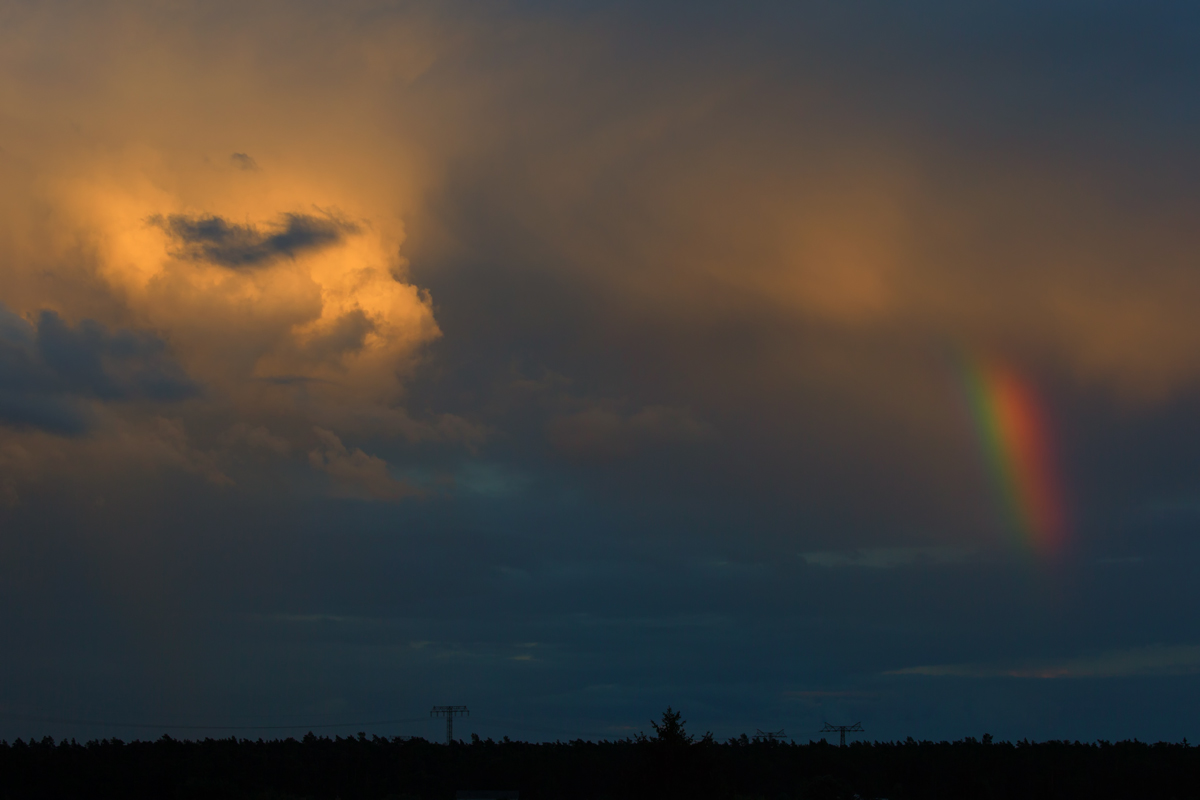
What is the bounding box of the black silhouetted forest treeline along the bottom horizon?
[0,716,1200,800]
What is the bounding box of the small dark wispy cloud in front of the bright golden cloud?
[150,213,359,269]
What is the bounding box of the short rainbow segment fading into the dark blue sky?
[962,359,1067,557]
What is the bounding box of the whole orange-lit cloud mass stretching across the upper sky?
[0,2,1200,544]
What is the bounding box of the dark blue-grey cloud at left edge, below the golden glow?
[0,306,198,435]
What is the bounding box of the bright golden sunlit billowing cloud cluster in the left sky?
[0,5,465,494]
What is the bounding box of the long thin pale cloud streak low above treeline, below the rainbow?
[884,644,1200,679]
